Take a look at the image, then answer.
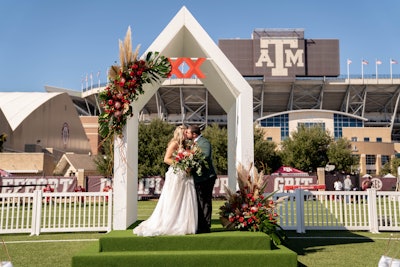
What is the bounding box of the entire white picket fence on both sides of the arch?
[0,189,400,235]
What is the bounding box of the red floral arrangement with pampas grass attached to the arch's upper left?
[99,27,172,138]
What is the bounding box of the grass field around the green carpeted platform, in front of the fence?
[0,201,400,267]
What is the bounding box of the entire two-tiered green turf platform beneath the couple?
[72,230,297,267]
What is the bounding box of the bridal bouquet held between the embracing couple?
[172,145,207,176]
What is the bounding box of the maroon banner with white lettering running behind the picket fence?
[0,174,397,199]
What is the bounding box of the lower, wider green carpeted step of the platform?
[72,245,297,267]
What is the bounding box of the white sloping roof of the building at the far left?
[0,92,60,131]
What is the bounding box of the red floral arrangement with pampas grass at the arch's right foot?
[219,164,287,245]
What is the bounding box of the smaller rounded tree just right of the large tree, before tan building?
[327,138,359,173]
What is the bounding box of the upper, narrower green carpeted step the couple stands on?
[99,230,272,252]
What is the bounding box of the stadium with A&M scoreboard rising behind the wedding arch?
[0,22,400,178]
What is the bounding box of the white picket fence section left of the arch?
[0,190,112,235]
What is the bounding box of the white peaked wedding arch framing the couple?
[113,7,254,230]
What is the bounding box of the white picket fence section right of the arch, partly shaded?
[274,189,400,233]
